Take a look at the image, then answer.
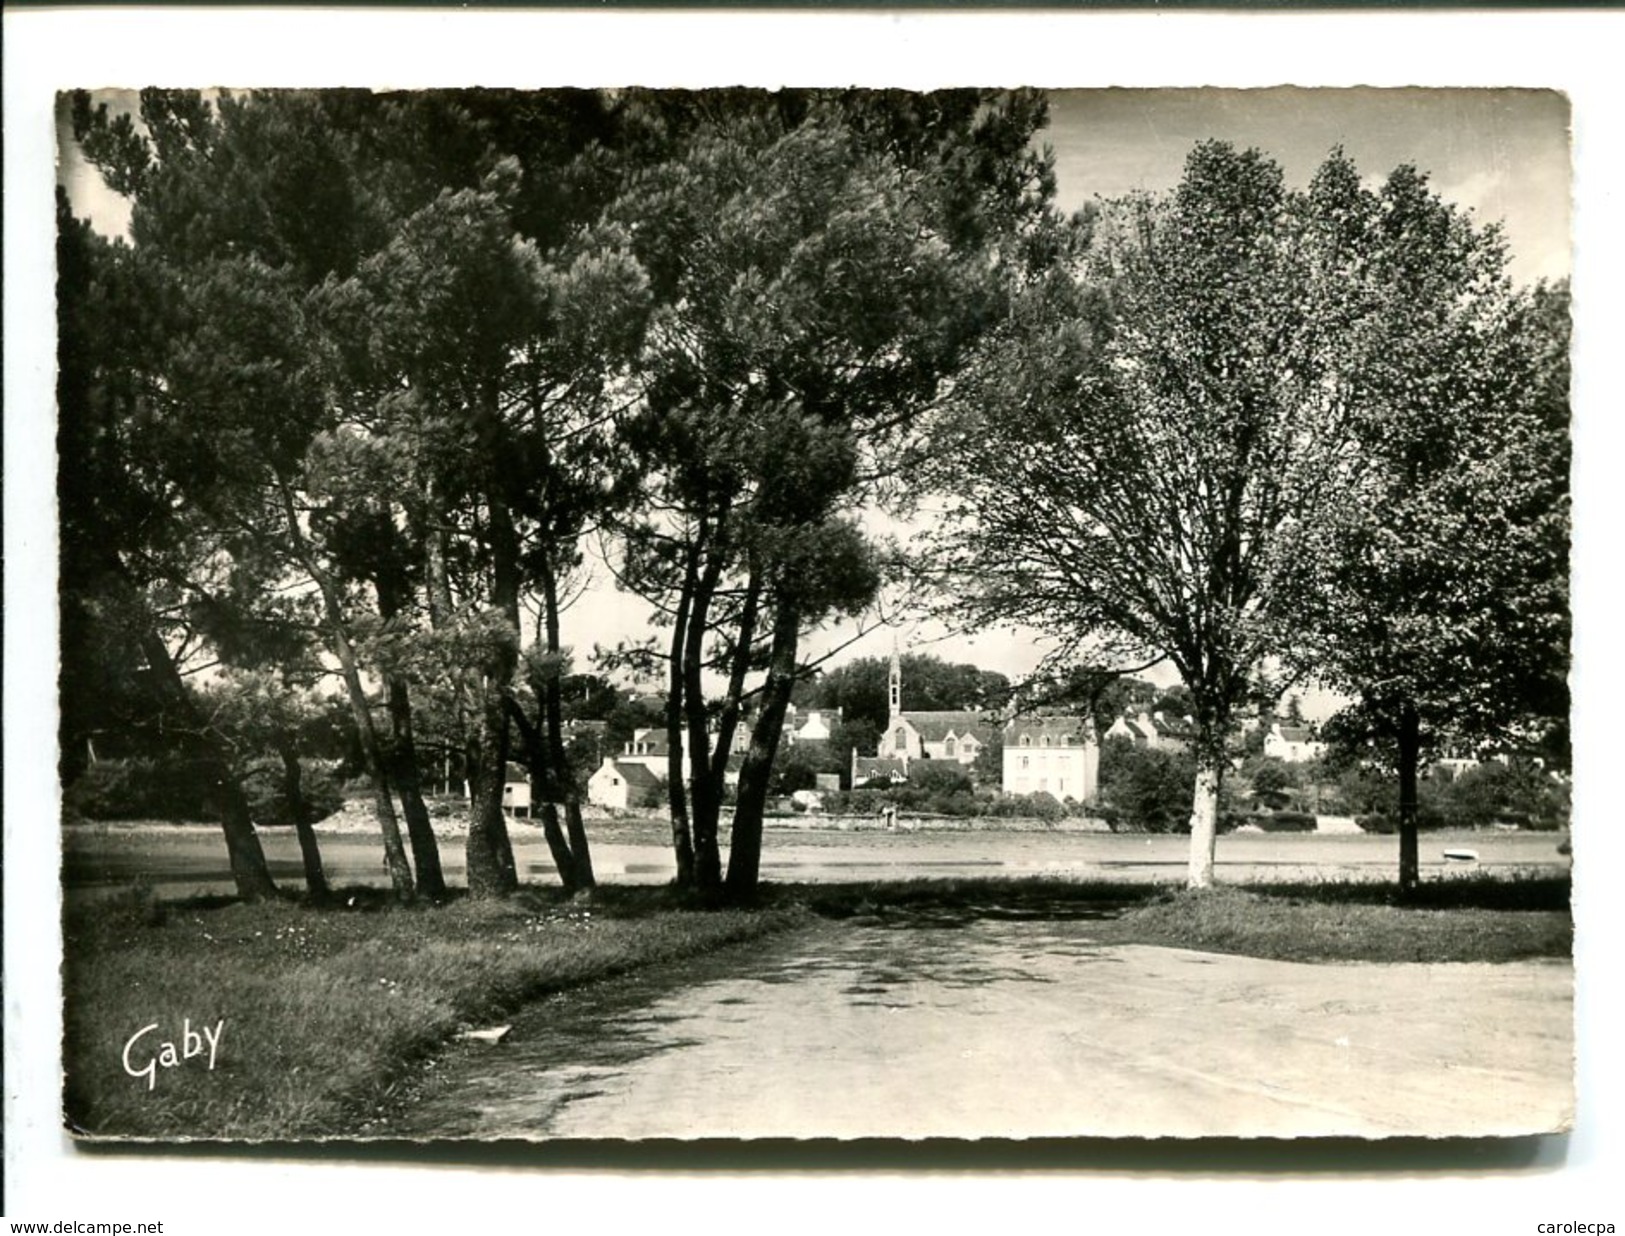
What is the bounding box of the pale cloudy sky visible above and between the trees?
[57,88,1571,715]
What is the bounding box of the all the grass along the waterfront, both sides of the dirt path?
[63,877,1573,1140]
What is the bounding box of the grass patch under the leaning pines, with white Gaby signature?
[63,890,804,1140]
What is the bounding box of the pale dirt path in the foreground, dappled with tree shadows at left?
[380,921,1573,1139]
